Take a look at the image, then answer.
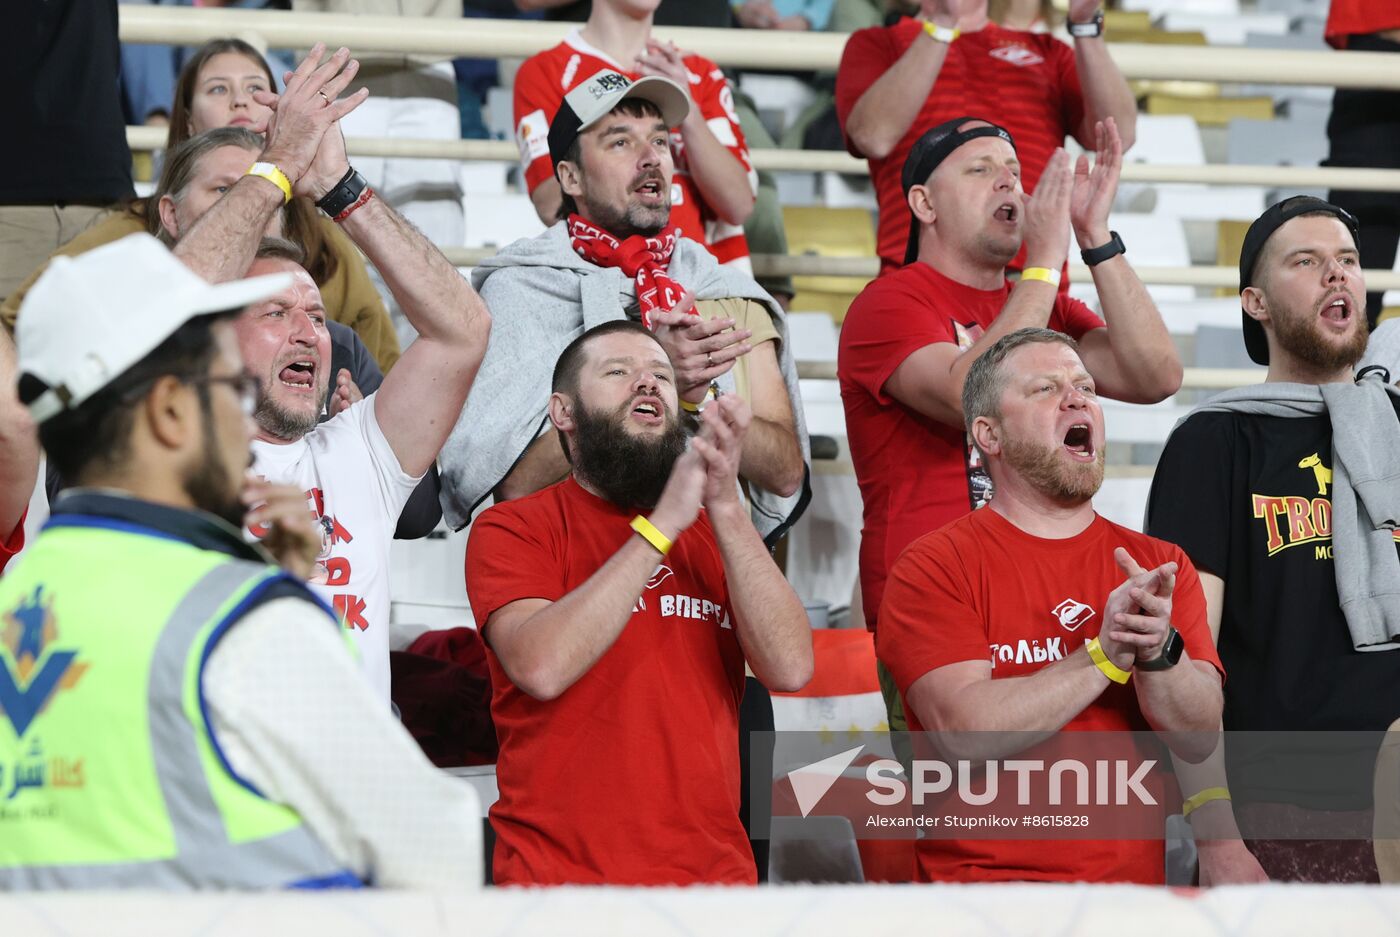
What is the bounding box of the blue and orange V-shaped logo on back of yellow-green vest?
[0,585,88,737]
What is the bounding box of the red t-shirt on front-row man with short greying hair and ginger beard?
[875,511,1224,884]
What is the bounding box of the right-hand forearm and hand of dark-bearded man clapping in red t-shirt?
[692,396,813,693]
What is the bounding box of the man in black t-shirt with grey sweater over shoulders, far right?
[1147,196,1400,882]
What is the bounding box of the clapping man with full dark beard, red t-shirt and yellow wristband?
[466,322,813,885]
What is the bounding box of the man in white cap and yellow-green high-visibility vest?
[0,234,482,891]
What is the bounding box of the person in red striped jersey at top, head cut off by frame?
[836,0,1137,275]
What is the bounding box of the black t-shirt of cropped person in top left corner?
[0,0,134,204]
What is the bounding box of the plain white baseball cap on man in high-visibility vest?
[15,234,291,423]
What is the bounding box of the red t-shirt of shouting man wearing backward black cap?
[836,263,1103,630]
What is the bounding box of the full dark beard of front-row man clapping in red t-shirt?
[573,398,686,511]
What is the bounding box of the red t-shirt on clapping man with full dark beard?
[466,478,757,885]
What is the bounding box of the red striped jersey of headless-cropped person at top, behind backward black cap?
[836,18,1092,275]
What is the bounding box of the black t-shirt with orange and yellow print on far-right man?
[1147,398,1400,805]
